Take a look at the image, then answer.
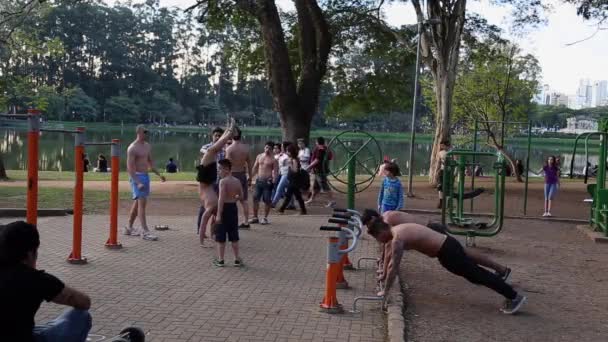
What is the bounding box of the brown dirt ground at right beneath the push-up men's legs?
[401,220,608,342]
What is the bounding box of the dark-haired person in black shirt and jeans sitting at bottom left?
[0,221,91,342]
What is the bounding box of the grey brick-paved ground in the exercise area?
[0,215,386,342]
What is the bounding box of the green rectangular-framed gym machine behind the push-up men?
[441,150,506,246]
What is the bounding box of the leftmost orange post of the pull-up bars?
[26,109,40,225]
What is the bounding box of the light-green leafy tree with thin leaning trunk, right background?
[453,41,540,181]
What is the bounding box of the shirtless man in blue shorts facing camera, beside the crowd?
[249,141,279,224]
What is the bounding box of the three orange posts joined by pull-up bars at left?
[0,109,121,264]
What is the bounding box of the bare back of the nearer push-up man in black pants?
[391,223,447,258]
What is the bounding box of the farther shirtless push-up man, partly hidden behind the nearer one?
[361,209,511,281]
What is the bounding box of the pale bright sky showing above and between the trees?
[107,0,608,94]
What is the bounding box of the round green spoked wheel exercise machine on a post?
[323,130,382,209]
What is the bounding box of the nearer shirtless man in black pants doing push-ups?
[367,219,526,314]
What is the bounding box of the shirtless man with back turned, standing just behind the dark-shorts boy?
[226,128,251,229]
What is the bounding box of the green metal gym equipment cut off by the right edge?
[570,132,608,237]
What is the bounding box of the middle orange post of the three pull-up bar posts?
[68,127,87,264]
